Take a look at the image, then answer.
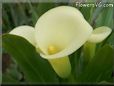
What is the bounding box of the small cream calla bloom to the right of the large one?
[88,26,112,43]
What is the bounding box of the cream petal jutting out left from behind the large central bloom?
[9,26,35,46]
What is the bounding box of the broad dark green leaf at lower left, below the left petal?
[2,34,58,83]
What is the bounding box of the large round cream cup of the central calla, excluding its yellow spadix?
[35,6,93,59]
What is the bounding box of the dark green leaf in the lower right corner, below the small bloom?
[78,45,114,83]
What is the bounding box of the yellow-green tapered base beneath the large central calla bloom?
[48,56,71,78]
